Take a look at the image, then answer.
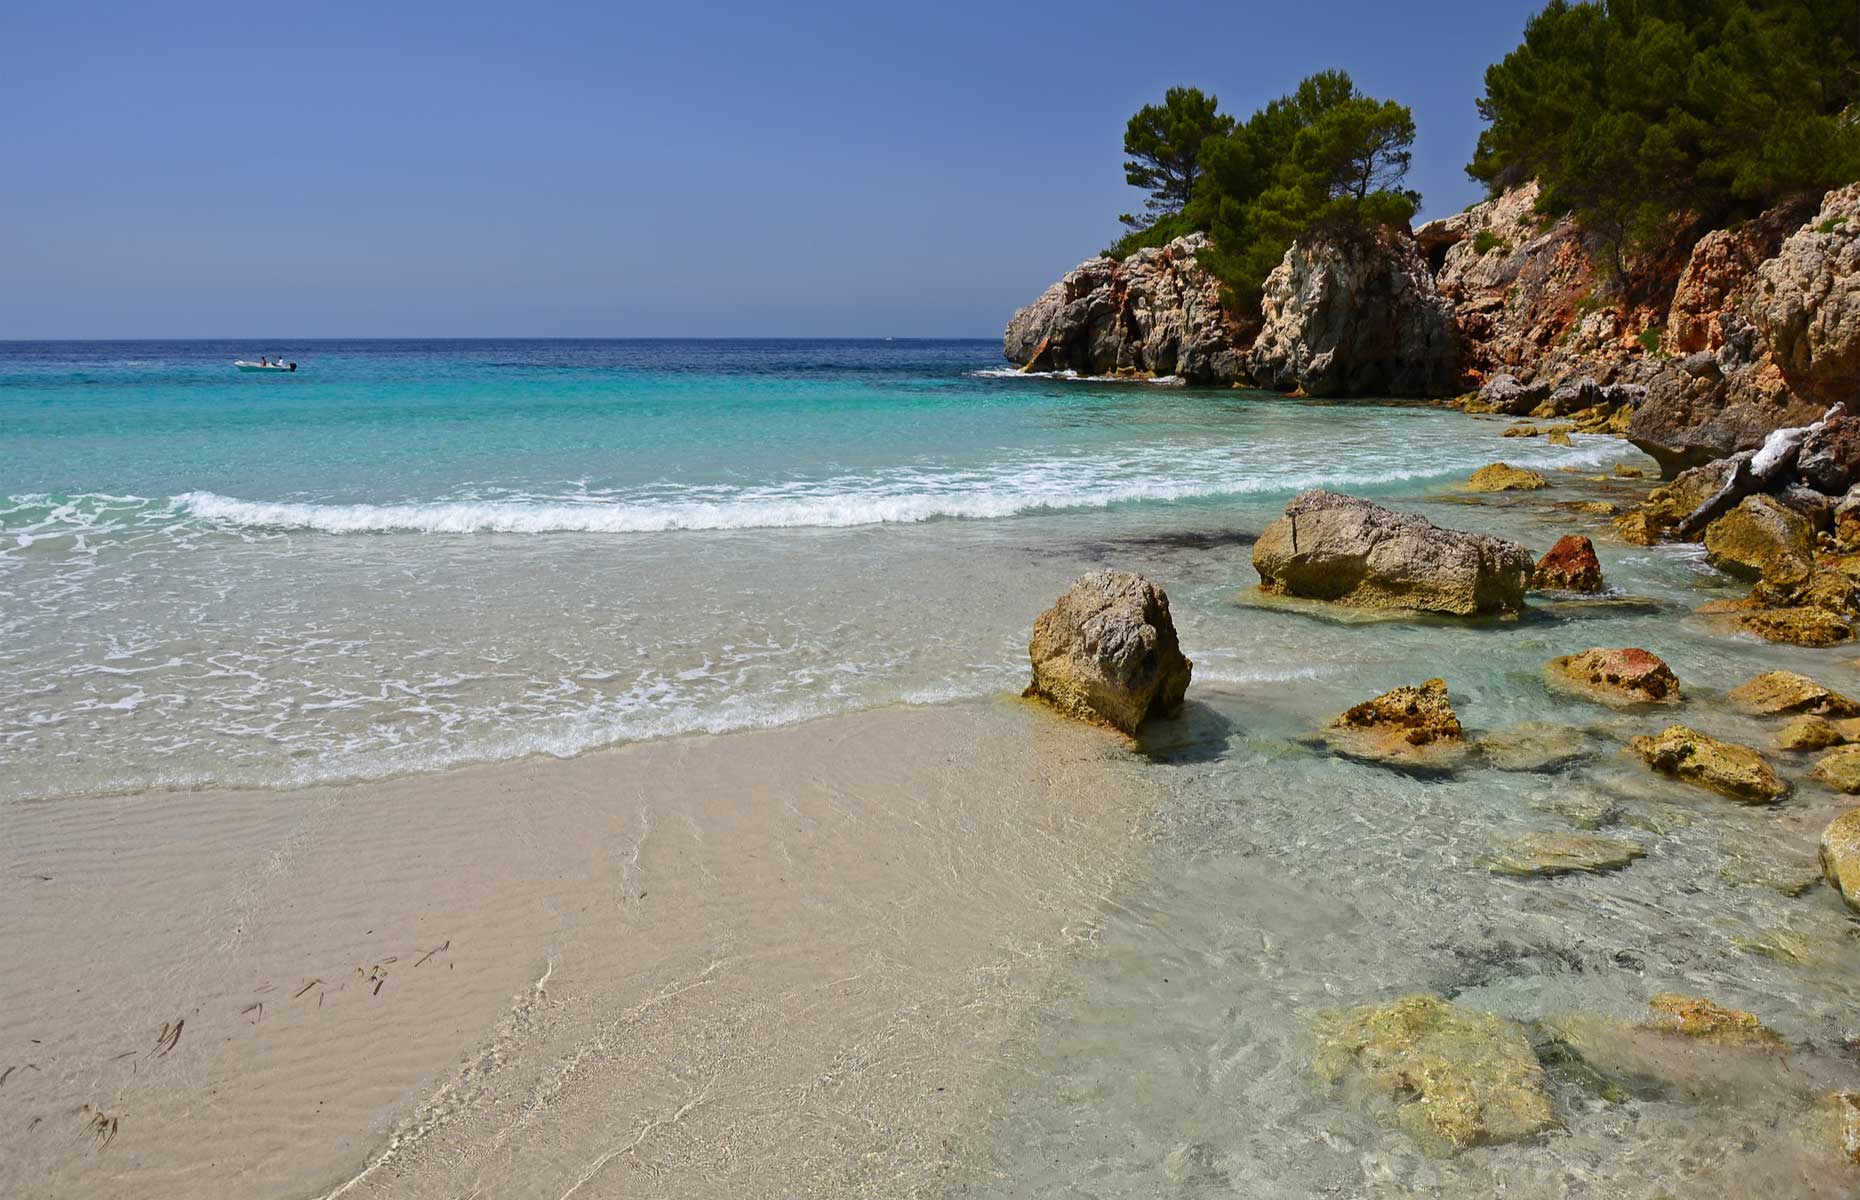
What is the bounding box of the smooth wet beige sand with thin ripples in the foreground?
[0,700,1151,1200]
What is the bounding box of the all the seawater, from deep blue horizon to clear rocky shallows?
[0,342,1860,1196]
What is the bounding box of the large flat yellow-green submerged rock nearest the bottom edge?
[1313,993,1557,1155]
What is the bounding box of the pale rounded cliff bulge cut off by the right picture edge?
[1750,184,1860,402]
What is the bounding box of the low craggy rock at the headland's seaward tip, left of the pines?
[1003,233,1252,383]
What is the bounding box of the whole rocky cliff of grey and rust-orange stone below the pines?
[1004,184,1860,463]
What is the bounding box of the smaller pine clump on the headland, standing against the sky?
[1109,71,1421,307]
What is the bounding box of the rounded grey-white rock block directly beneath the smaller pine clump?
[1246,234,1460,396]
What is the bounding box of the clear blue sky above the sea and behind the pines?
[0,0,1540,339]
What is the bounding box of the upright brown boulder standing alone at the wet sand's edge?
[1027,571,1194,733]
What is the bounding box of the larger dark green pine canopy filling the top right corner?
[1468,0,1860,273]
